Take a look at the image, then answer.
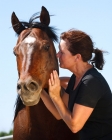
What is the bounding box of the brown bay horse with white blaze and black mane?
[11,6,79,140]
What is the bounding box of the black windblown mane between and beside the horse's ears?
[18,13,58,42]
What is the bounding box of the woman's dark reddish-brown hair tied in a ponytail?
[60,29,104,70]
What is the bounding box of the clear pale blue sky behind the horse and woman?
[0,0,112,131]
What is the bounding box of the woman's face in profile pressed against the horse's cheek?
[57,40,74,70]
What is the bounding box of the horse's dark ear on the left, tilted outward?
[11,12,25,35]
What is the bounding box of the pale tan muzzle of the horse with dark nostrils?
[17,78,42,106]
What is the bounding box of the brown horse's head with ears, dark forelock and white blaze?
[11,6,58,106]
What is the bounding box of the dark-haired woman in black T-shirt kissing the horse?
[41,30,112,140]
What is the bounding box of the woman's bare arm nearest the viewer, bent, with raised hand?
[49,71,93,133]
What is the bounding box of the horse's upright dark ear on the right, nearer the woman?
[40,6,50,26]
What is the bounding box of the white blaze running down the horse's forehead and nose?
[22,36,36,73]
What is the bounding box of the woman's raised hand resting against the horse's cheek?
[49,70,61,99]
